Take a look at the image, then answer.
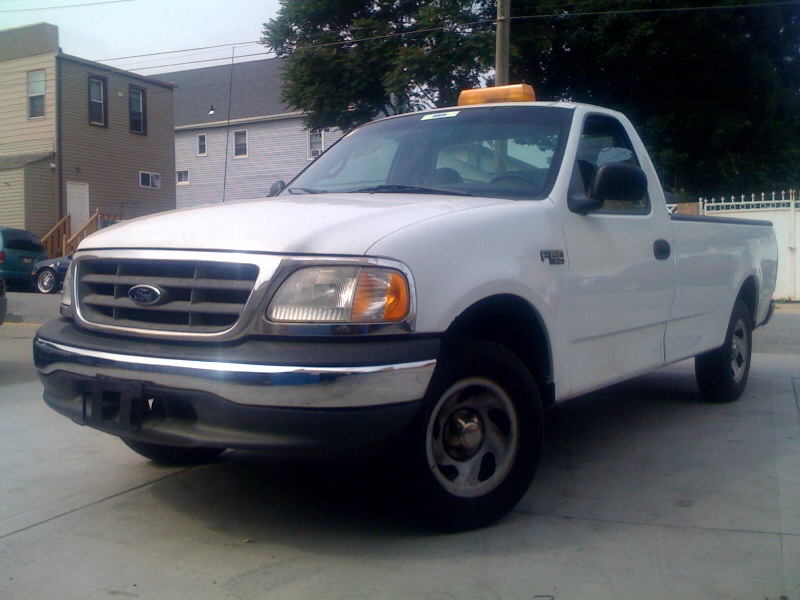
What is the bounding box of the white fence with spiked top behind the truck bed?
[698,189,800,301]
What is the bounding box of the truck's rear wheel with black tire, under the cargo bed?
[694,300,753,402]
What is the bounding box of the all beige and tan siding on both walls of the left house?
[0,23,175,236]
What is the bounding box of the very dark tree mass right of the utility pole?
[511,0,800,193]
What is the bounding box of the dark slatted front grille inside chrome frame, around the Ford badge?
[76,259,258,334]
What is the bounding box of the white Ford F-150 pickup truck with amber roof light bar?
[34,86,777,530]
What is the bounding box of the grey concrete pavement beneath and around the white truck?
[0,292,800,600]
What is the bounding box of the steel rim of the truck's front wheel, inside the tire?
[426,377,519,498]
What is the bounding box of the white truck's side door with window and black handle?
[564,114,674,395]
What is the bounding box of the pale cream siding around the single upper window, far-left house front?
[0,54,56,155]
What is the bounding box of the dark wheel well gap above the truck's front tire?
[445,294,555,407]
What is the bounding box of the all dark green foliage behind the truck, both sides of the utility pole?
[262,0,800,195]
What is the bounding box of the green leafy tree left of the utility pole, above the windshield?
[262,0,494,130]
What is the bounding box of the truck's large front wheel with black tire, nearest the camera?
[405,338,543,532]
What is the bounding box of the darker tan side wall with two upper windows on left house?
[58,56,175,219]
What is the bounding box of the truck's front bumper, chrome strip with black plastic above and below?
[33,320,438,455]
